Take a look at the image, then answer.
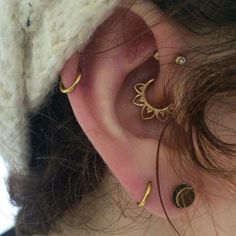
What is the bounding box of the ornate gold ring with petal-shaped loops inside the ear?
[133,79,174,122]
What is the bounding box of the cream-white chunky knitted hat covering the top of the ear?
[0,0,120,171]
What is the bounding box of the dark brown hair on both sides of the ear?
[6,0,236,235]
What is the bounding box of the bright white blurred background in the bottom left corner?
[0,157,17,235]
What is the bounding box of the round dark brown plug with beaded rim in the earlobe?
[173,184,195,208]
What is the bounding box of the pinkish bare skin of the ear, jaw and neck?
[53,1,236,236]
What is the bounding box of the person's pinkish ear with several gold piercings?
[61,2,195,216]
